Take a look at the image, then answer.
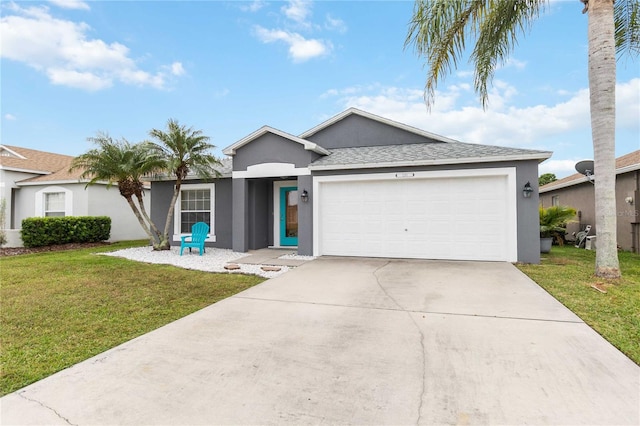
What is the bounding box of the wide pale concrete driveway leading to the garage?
[0,258,640,425]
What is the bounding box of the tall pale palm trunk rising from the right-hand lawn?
[588,0,620,278]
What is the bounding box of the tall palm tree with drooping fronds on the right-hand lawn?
[405,0,640,278]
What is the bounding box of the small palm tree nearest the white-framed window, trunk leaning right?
[149,119,220,250]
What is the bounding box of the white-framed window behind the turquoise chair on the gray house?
[174,184,215,241]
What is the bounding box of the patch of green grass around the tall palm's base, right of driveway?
[517,246,640,365]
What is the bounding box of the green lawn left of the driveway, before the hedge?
[0,242,264,395]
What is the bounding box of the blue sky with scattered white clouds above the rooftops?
[0,0,640,177]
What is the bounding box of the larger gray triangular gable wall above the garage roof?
[307,114,436,149]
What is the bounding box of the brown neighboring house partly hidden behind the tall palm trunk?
[540,150,640,253]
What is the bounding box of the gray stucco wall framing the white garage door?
[310,160,540,263]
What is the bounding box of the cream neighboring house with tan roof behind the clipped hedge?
[0,145,150,247]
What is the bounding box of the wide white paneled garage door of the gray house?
[315,169,517,261]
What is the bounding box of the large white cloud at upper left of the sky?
[0,4,184,91]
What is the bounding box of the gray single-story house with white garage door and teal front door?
[151,108,551,263]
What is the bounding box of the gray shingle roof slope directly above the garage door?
[310,142,551,170]
